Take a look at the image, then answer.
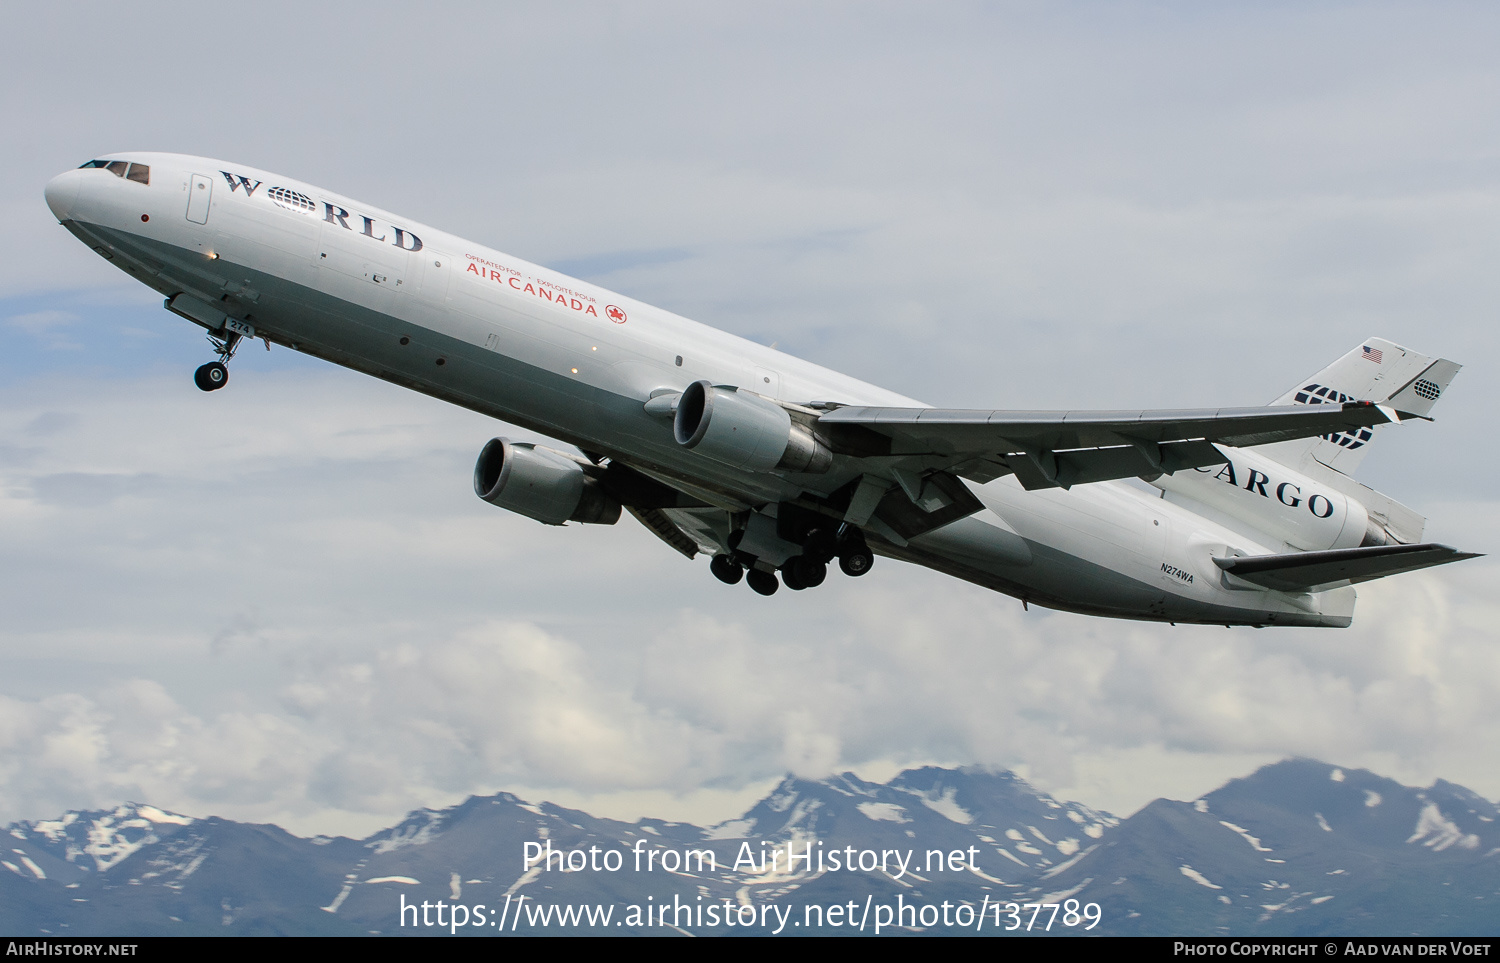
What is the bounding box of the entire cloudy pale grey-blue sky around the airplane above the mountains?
[0,3,1500,836]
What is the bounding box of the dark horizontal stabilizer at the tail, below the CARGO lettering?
[1214,543,1481,593]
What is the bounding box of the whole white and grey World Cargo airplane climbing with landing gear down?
[47,153,1473,627]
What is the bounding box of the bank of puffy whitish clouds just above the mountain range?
[0,555,1500,831]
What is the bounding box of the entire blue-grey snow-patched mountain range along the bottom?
[0,761,1500,935]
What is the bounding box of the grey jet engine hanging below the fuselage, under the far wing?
[474,438,620,525]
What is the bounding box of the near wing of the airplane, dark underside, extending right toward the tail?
[816,402,1416,489]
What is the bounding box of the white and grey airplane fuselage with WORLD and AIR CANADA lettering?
[47,153,1358,626]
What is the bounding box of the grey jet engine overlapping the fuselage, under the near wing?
[672,381,834,474]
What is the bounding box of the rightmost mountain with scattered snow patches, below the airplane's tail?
[1032,759,1500,936]
